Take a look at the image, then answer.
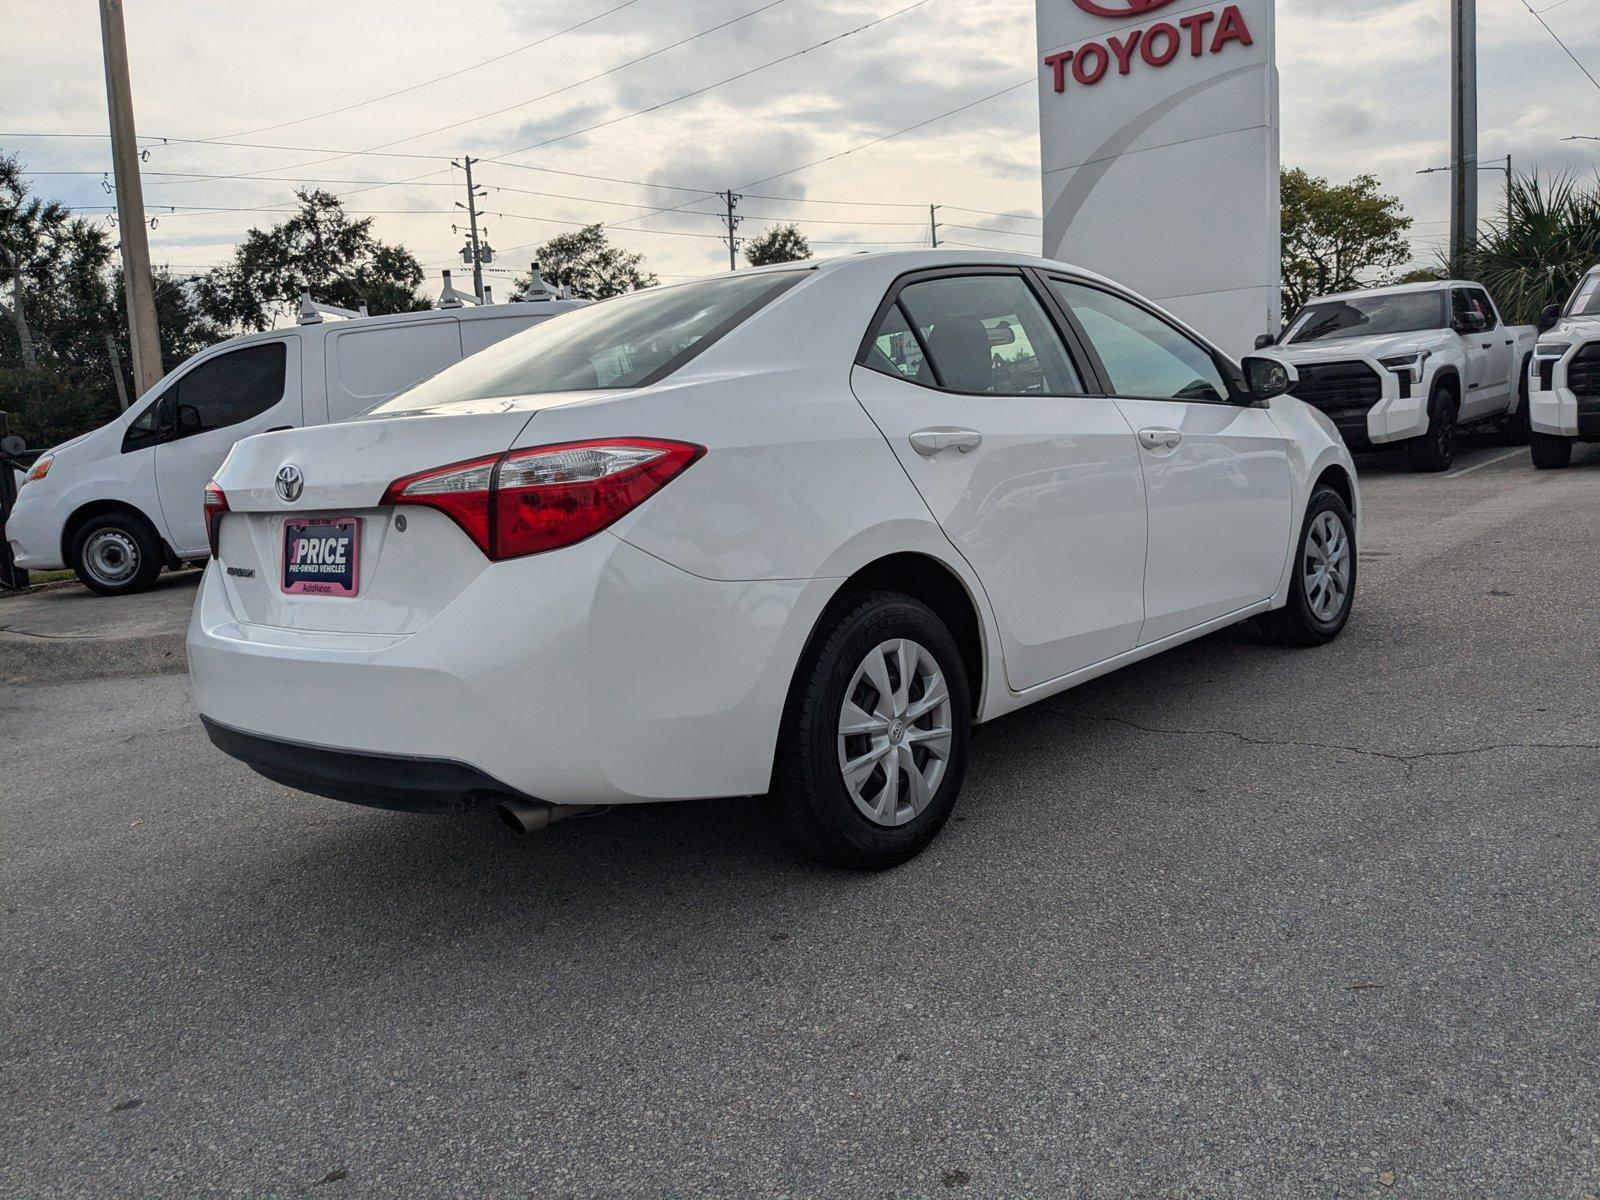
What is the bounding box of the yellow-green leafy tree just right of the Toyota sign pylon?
[1282,168,1411,315]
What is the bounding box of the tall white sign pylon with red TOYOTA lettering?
[1037,0,1280,354]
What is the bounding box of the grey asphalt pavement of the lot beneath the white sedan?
[0,448,1600,1200]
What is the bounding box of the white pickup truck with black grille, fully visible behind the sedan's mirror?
[1258,280,1539,470]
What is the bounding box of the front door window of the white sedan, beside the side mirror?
[1050,278,1229,400]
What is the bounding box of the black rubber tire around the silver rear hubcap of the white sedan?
[771,592,973,870]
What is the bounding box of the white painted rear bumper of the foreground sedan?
[189,533,837,806]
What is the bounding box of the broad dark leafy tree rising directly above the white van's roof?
[198,190,432,330]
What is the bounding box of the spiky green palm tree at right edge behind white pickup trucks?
[1445,174,1600,325]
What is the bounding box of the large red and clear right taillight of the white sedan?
[382,437,706,562]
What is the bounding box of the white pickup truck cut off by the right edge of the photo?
[1528,266,1600,470]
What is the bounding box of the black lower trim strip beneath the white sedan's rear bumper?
[200,714,533,813]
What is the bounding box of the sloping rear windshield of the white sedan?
[371,270,808,413]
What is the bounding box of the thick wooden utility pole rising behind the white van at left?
[101,0,165,395]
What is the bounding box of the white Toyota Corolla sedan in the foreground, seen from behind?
[189,251,1358,867]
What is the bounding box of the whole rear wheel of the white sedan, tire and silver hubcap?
[771,592,971,870]
